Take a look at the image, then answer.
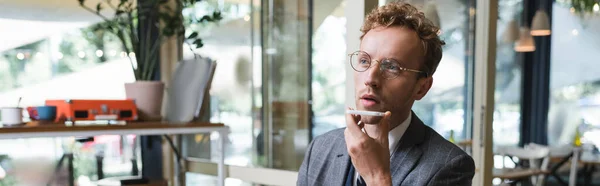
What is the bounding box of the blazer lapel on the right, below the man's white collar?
[391,112,425,185]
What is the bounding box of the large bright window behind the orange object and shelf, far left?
[0,17,137,185]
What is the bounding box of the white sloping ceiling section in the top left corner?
[0,0,116,52]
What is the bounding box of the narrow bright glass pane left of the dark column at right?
[493,0,523,146]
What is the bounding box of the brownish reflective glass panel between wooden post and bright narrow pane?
[259,0,311,171]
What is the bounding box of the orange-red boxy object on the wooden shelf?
[46,99,138,122]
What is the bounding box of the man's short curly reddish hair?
[360,2,446,76]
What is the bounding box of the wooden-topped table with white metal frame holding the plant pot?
[0,121,229,186]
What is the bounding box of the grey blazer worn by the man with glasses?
[297,113,475,186]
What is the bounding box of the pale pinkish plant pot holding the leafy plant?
[125,81,165,121]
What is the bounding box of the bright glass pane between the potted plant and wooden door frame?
[182,0,261,169]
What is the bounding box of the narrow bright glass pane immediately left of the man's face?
[311,0,348,137]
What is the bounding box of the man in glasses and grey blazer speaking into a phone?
[297,3,475,186]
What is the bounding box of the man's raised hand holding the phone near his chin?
[344,108,392,185]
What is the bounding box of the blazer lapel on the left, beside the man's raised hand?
[324,136,350,185]
